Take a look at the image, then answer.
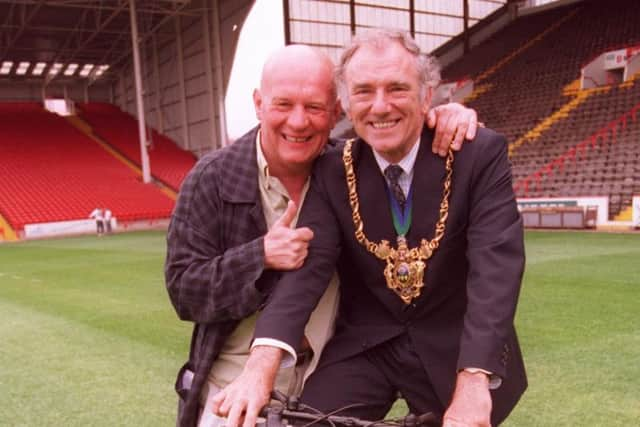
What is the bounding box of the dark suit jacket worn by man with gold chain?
[256,129,526,424]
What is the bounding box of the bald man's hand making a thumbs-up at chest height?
[264,201,313,270]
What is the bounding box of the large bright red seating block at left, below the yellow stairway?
[0,102,174,231]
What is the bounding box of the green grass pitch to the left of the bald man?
[0,233,190,426]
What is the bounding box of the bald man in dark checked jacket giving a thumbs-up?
[165,45,476,426]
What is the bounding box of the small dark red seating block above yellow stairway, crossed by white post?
[76,102,196,191]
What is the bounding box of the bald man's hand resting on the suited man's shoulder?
[427,102,478,156]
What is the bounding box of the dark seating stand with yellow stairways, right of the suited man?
[443,0,640,219]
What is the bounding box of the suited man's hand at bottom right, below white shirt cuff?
[442,371,492,427]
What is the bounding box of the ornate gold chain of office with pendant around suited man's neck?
[342,139,453,304]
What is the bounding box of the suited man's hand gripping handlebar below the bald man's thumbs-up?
[212,346,282,427]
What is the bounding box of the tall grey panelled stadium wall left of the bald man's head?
[114,0,253,156]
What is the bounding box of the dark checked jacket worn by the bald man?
[165,128,277,427]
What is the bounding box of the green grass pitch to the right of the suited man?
[505,232,640,426]
